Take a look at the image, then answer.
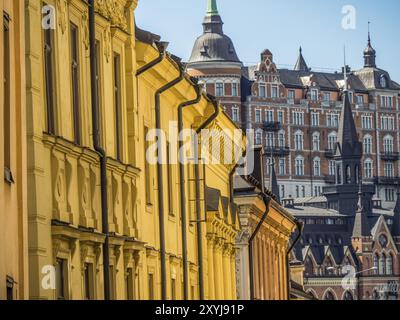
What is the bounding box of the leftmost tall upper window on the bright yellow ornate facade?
[43,5,56,134]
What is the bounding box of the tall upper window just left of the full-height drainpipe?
[71,23,81,144]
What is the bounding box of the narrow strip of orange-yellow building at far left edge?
[0,0,28,300]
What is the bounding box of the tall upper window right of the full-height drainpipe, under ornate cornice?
[114,53,122,161]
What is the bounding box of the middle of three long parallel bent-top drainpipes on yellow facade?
[178,85,201,300]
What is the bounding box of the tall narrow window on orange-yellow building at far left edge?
[3,14,12,175]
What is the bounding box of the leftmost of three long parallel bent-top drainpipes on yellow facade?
[155,65,184,300]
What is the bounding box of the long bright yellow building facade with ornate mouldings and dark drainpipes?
[25,0,244,300]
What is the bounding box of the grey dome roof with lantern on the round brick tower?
[188,10,241,66]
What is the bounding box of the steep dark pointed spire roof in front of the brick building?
[336,90,362,157]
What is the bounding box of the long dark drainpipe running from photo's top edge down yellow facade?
[89,0,110,300]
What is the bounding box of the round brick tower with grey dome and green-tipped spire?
[187,0,242,125]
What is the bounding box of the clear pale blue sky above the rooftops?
[136,0,400,82]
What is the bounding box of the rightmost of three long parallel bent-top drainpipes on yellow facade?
[194,95,219,300]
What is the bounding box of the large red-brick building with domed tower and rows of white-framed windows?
[187,1,400,209]
